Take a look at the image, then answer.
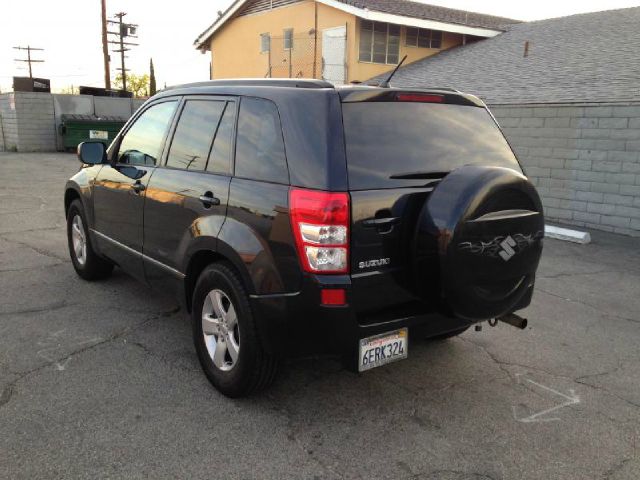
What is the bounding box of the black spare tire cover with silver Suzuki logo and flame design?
[413,166,544,320]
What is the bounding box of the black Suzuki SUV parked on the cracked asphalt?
[64,80,544,396]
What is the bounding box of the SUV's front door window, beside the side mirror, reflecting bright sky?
[118,101,178,166]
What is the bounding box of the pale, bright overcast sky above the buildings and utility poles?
[0,0,640,92]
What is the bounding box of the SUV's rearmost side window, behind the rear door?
[235,98,289,183]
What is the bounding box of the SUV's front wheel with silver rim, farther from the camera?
[67,200,113,281]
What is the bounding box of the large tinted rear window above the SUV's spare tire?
[342,102,521,190]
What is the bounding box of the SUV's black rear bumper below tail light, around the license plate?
[251,275,471,356]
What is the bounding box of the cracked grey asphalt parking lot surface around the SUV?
[0,153,640,480]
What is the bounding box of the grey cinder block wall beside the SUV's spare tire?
[491,104,640,236]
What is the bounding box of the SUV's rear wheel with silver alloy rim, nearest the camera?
[191,263,279,398]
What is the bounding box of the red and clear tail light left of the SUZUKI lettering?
[289,189,349,273]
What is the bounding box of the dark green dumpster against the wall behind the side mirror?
[60,115,127,150]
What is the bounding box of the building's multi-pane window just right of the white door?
[359,20,400,64]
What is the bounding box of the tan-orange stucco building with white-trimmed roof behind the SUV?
[195,0,516,84]
